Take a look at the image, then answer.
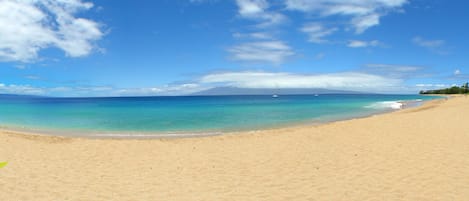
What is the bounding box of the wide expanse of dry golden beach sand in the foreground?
[0,97,469,201]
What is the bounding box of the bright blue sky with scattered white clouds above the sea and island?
[0,0,469,96]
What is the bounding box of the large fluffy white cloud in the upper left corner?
[0,0,103,62]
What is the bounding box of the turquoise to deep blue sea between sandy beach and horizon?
[0,94,437,135]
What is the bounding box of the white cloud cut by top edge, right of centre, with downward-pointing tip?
[285,0,407,34]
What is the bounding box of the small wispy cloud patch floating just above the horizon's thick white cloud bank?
[228,40,295,64]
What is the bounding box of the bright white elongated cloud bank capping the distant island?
[200,71,402,92]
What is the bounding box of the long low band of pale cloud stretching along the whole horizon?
[0,67,436,97]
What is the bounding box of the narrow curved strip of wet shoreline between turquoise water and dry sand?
[0,96,438,139]
